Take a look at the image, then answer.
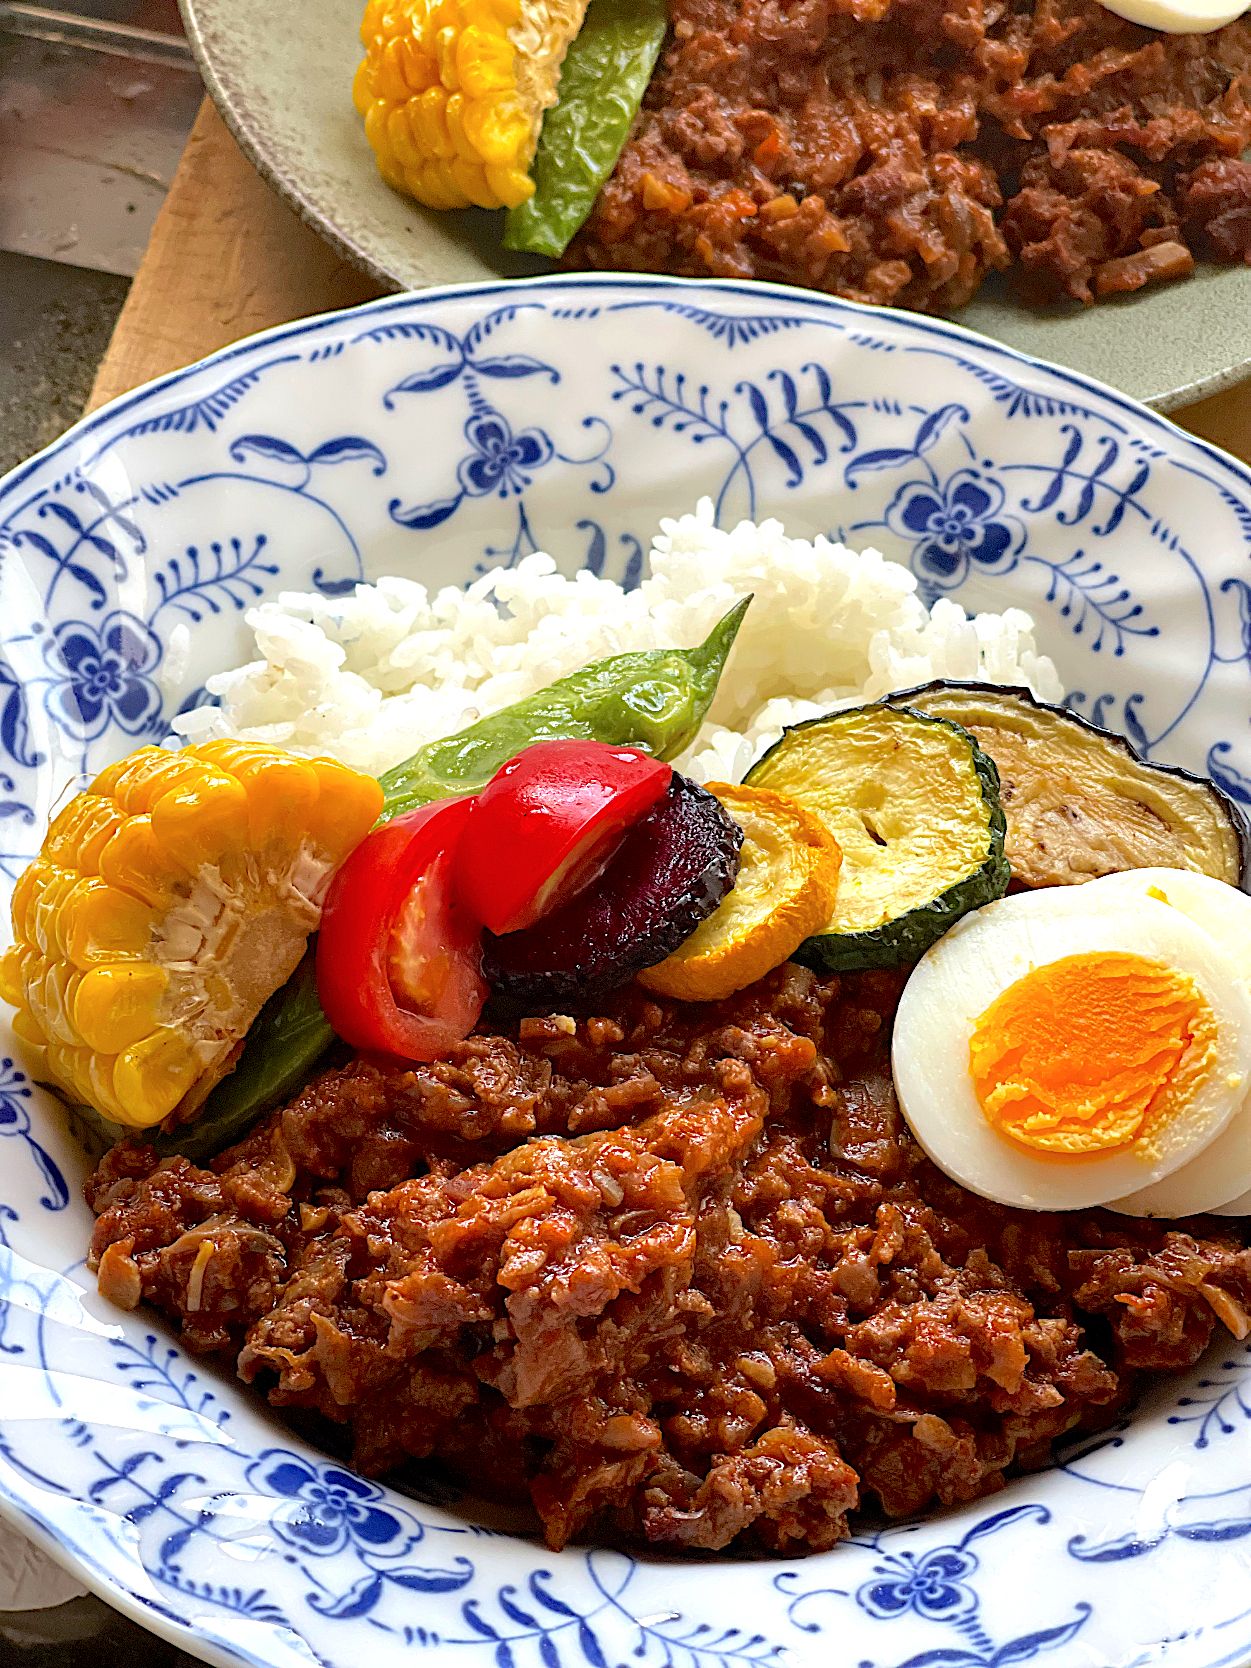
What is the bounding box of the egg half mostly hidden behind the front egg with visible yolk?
[1088,869,1251,1216]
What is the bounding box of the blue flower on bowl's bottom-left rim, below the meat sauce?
[247,1448,422,1558]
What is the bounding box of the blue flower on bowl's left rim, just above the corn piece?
[43,610,162,741]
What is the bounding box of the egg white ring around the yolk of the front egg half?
[891,882,1251,1211]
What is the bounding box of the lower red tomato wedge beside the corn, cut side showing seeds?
[317,799,487,1061]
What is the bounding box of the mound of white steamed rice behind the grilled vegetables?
[173,499,1063,782]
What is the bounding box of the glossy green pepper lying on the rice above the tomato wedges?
[382,597,751,817]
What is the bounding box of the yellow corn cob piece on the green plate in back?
[352,0,587,209]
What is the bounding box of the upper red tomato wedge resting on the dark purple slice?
[455,741,674,932]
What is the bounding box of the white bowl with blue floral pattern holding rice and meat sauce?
[0,277,1251,1668]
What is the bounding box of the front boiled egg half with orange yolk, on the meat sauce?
[892,881,1251,1211]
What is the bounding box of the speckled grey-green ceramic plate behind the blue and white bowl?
[180,0,1251,412]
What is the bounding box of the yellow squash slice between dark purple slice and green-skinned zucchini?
[639,782,842,1002]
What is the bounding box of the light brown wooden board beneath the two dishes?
[87,98,1251,462]
